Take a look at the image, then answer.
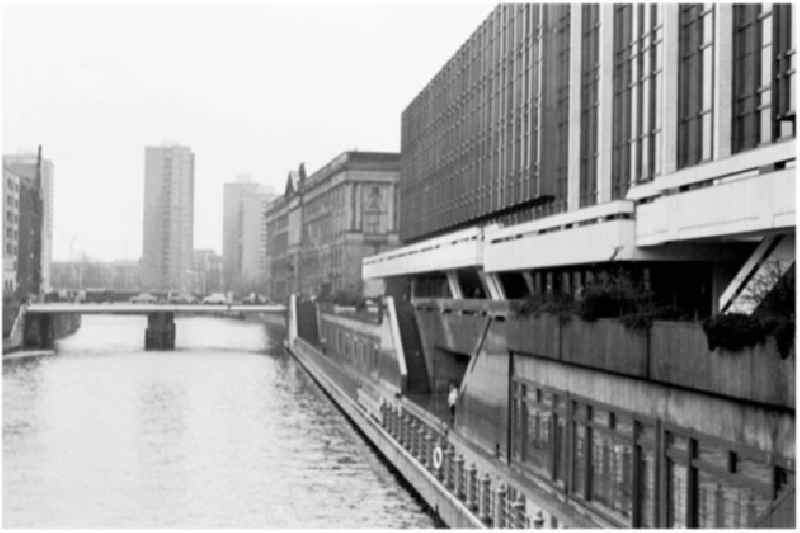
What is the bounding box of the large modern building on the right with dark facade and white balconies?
[360,3,797,527]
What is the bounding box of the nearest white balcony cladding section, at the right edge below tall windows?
[636,168,797,246]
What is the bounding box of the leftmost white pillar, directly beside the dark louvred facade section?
[567,4,583,211]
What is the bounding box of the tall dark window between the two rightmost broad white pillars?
[678,4,714,168]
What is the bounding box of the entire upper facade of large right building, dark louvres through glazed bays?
[399,3,796,242]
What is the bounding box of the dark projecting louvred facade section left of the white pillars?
[400,4,570,241]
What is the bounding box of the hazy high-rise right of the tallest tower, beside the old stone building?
[222,176,275,290]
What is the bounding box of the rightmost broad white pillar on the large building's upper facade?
[713,2,732,160]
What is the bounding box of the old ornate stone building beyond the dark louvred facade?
[267,152,400,299]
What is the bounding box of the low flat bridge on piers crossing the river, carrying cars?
[23,302,286,350]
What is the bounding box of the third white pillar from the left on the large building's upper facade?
[656,3,680,175]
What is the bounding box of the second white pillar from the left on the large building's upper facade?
[597,3,614,204]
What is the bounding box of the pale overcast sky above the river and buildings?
[2,3,492,260]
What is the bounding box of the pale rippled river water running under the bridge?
[3,316,434,528]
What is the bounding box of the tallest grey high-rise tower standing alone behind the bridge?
[142,145,194,291]
